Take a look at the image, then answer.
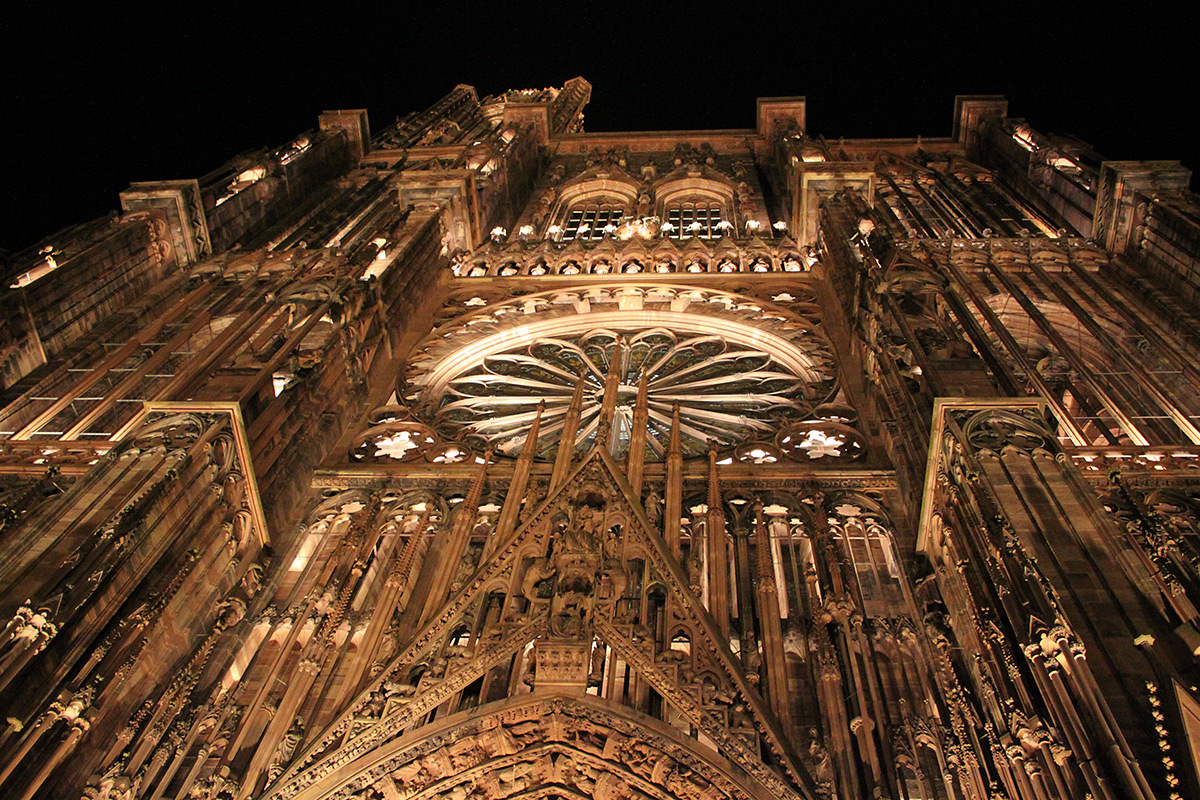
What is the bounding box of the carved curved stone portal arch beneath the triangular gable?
[279,694,806,800]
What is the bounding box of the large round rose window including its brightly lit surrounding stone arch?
[401,287,857,463]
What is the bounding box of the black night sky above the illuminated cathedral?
[0,0,1200,251]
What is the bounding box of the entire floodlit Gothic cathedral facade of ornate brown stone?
[0,78,1200,800]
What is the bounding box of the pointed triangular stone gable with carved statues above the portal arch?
[269,447,814,796]
